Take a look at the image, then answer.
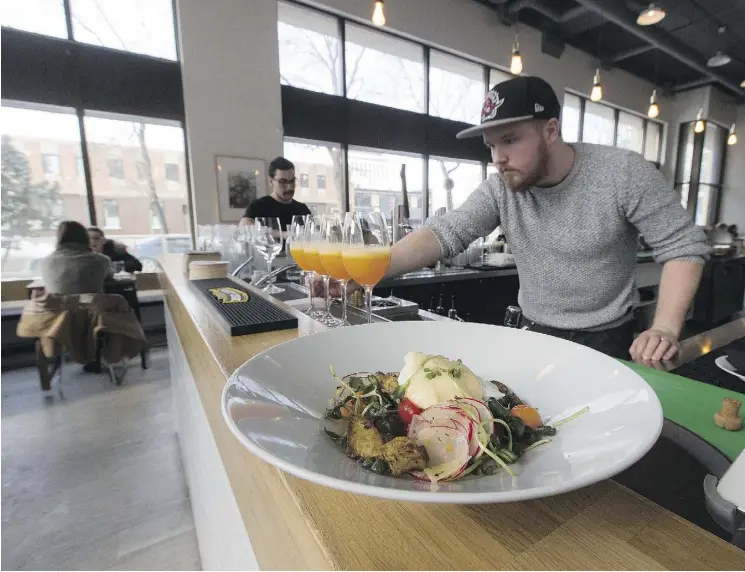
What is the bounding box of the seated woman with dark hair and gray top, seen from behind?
[41,220,111,294]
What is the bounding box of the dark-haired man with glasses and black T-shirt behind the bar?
[240,157,311,229]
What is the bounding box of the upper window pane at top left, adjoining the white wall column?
[70,0,176,60]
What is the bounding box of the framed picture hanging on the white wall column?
[215,155,266,222]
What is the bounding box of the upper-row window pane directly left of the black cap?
[429,50,486,125]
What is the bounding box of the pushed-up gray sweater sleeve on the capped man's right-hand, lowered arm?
[620,153,710,264]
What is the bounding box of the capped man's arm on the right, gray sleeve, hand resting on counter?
[621,154,710,362]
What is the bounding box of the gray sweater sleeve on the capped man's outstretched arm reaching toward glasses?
[425,178,502,258]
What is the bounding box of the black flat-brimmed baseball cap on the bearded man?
[456,75,561,139]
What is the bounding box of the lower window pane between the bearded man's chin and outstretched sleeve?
[429,157,484,215]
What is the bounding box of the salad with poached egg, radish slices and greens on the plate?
[325,352,586,483]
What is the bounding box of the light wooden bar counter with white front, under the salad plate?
[160,255,745,570]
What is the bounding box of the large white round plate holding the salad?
[222,321,662,504]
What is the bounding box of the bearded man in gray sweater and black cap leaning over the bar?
[388,77,709,364]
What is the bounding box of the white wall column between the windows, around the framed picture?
[177,0,282,224]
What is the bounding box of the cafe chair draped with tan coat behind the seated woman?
[17,293,147,395]
